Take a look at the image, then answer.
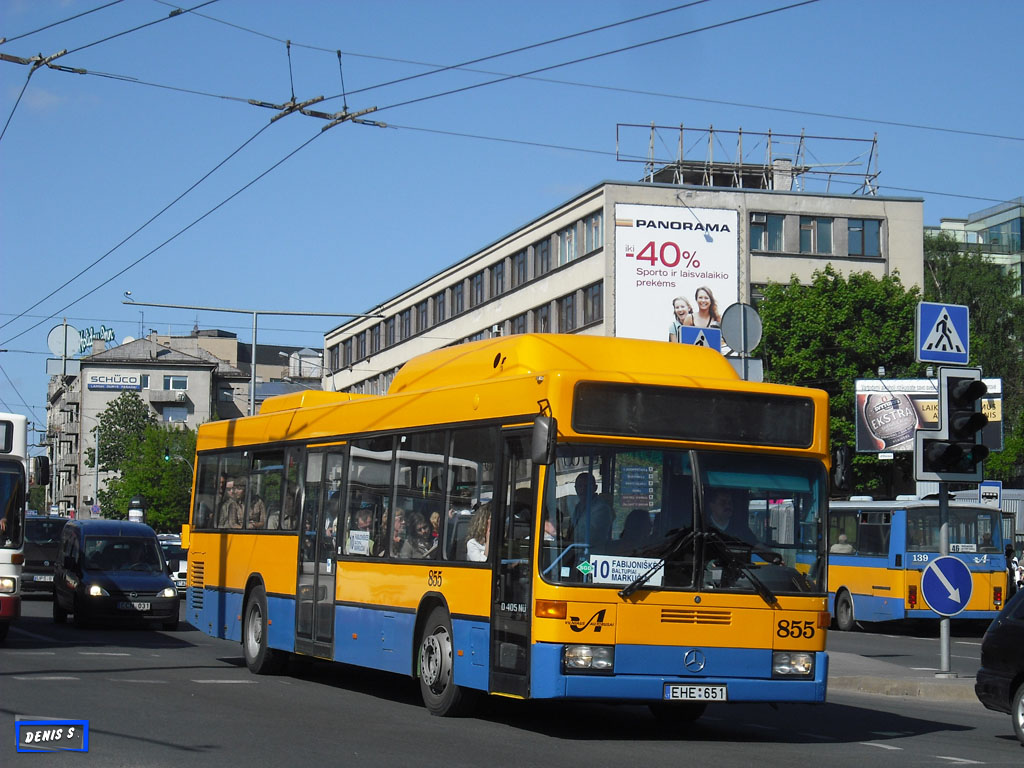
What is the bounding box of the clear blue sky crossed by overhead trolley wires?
[0,0,1024,444]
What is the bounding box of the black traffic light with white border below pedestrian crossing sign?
[914,368,988,482]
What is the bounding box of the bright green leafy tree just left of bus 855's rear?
[100,424,196,532]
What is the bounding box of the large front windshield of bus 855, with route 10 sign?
[540,444,827,594]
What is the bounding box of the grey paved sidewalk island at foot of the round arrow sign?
[828,651,978,702]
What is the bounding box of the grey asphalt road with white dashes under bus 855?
[0,600,1024,768]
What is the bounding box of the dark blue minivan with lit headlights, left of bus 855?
[53,520,179,630]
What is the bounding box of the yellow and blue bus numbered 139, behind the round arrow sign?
[828,499,1007,631]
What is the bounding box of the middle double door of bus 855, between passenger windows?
[295,447,345,658]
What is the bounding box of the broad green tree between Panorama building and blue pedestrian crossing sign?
[758,264,924,495]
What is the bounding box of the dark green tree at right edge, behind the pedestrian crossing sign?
[925,232,1024,487]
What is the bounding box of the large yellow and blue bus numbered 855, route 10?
[183,334,830,721]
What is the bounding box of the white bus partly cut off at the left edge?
[0,414,49,641]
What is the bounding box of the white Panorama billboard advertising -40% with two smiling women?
[615,204,739,341]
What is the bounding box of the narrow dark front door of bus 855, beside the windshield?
[489,433,537,698]
